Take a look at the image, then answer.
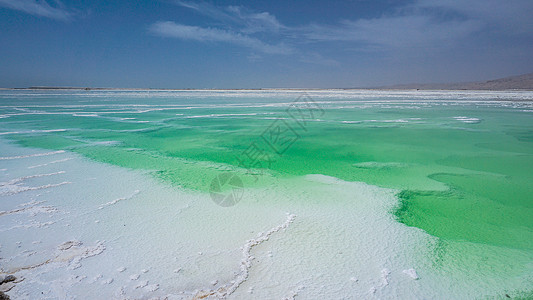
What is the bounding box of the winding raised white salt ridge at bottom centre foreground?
[193,214,296,299]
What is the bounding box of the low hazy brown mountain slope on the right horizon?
[384,73,533,90]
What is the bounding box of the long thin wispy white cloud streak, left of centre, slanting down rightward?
[150,21,292,54]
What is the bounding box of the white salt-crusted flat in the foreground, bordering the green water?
[0,139,528,299]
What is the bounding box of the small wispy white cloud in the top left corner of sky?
[0,0,73,21]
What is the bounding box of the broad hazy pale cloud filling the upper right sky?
[293,0,533,51]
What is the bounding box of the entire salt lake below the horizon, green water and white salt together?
[0,90,533,299]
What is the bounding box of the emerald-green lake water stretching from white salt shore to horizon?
[0,91,533,251]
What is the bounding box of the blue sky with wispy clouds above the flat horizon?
[0,0,533,88]
